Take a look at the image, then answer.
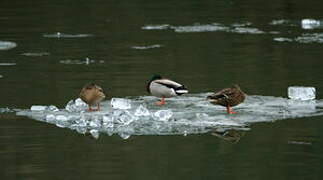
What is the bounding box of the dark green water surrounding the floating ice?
[0,0,323,180]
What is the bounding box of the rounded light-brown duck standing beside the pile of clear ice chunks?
[80,83,105,111]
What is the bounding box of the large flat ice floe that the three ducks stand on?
[16,93,323,139]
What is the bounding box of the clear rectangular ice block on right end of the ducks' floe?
[288,86,315,101]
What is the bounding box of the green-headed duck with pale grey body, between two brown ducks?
[147,75,188,105]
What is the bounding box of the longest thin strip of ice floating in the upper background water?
[142,22,266,34]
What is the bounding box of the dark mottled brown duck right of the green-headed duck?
[207,85,246,114]
